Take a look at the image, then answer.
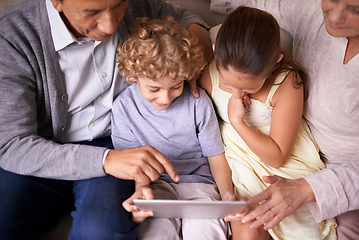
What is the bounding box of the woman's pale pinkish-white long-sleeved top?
[211,0,359,221]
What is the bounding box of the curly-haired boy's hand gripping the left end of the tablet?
[122,186,154,223]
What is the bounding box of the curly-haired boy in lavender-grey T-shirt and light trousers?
[112,18,236,240]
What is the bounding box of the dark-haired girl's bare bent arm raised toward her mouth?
[228,73,303,168]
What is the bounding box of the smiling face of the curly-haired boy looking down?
[136,77,184,110]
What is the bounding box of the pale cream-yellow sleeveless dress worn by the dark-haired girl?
[209,61,336,240]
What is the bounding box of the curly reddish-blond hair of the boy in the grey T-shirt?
[117,17,206,83]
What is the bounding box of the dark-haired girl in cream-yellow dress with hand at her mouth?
[199,7,336,240]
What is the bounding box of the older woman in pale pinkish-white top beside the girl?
[211,0,359,240]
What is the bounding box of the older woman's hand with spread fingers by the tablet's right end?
[242,176,315,230]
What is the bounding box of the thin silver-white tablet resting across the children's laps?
[133,199,248,219]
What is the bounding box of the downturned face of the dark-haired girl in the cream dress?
[218,66,268,97]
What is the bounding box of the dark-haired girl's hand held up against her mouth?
[228,95,251,126]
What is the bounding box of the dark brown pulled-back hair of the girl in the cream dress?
[214,6,306,94]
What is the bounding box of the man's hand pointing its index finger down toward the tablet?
[104,146,179,185]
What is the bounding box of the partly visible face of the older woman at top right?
[322,0,359,38]
